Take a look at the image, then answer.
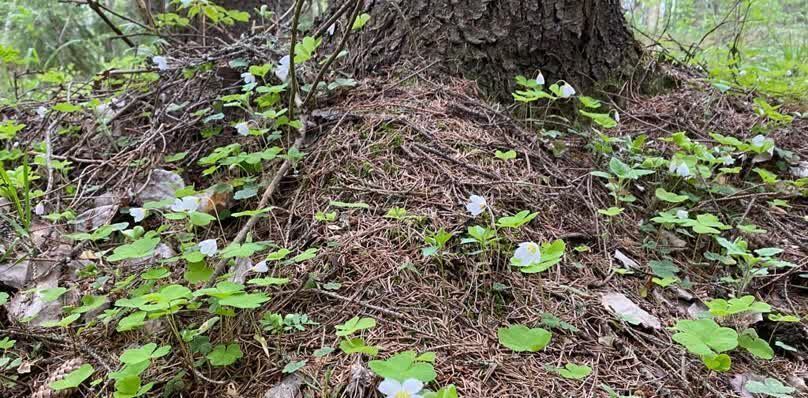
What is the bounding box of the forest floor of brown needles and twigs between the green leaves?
[0,40,808,397]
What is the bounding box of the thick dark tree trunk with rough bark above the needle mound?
[352,0,640,98]
